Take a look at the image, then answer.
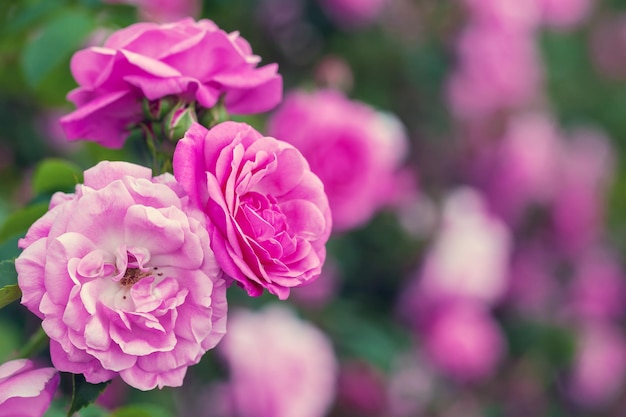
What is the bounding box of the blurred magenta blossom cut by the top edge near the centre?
[319,0,392,29]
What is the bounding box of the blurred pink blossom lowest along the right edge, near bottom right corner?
[569,322,626,407]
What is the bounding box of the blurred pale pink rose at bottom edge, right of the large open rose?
[218,306,337,417]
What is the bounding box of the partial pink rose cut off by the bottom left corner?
[0,359,60,417]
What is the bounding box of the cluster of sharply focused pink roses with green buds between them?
[6,18,332,415]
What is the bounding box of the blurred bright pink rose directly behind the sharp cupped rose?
[268,90,408,232]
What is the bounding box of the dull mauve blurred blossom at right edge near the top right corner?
[590,13,626,80]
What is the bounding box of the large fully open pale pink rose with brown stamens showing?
[15,161,226,390]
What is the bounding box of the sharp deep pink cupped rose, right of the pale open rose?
[174,122,332,299]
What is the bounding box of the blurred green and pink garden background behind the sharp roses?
[0,0,626,417]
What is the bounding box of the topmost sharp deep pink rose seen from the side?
[61,18,282,148]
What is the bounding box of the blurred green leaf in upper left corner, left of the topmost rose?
[21,10,94,87]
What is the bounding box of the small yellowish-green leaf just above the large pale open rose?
[33,158,83,194]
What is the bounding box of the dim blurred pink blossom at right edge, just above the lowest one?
[568,249,626,320]
